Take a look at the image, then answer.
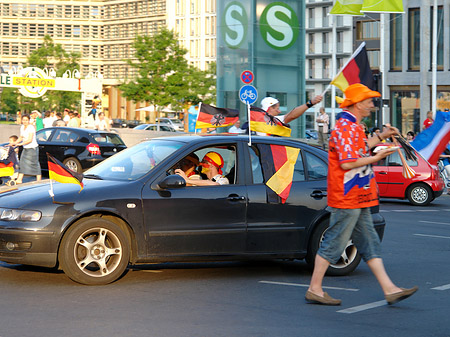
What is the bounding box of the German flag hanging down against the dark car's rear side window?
[258,144,300,204]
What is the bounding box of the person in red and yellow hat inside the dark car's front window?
[175,151,230,186]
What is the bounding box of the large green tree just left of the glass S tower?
[120,28,215,121]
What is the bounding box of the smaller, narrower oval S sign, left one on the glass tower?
[222,1,248,48]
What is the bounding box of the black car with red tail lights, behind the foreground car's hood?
[36,127,126,175]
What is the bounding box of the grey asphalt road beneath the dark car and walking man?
[0,195,450,337]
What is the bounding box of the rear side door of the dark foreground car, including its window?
[246,143,328,254]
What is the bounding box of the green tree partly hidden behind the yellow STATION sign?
[22,35,81,111]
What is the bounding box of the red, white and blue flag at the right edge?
[411,110,450,165]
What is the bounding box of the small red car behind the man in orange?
[373,144,445,206]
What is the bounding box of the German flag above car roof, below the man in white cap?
[250,106,291,137]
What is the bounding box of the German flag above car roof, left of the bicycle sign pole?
[195,103,239,129]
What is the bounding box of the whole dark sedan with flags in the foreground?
[0,135,385,284]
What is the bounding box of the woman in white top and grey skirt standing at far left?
[11,115,42,184]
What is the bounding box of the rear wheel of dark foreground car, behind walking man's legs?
[306,220,361,276]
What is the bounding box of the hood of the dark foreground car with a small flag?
[0,179,138,209]
